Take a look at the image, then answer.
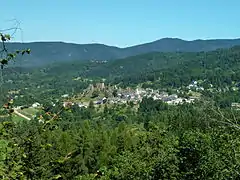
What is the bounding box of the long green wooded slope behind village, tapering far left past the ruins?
[32,46,240,89]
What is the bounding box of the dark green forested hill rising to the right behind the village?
[108,46,240,87]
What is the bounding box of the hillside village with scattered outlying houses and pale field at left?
[4,77,240,120]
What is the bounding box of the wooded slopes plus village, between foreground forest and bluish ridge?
[2,46,240,121]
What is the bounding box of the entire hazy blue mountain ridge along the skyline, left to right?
[7,38,240,66]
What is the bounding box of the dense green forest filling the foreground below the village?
[0,96,240,180]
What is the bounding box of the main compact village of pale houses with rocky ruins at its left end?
[62,82,202,107]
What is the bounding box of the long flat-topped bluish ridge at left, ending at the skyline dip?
[7,42,123,66]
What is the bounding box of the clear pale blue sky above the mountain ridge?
[0,0,240,47]
